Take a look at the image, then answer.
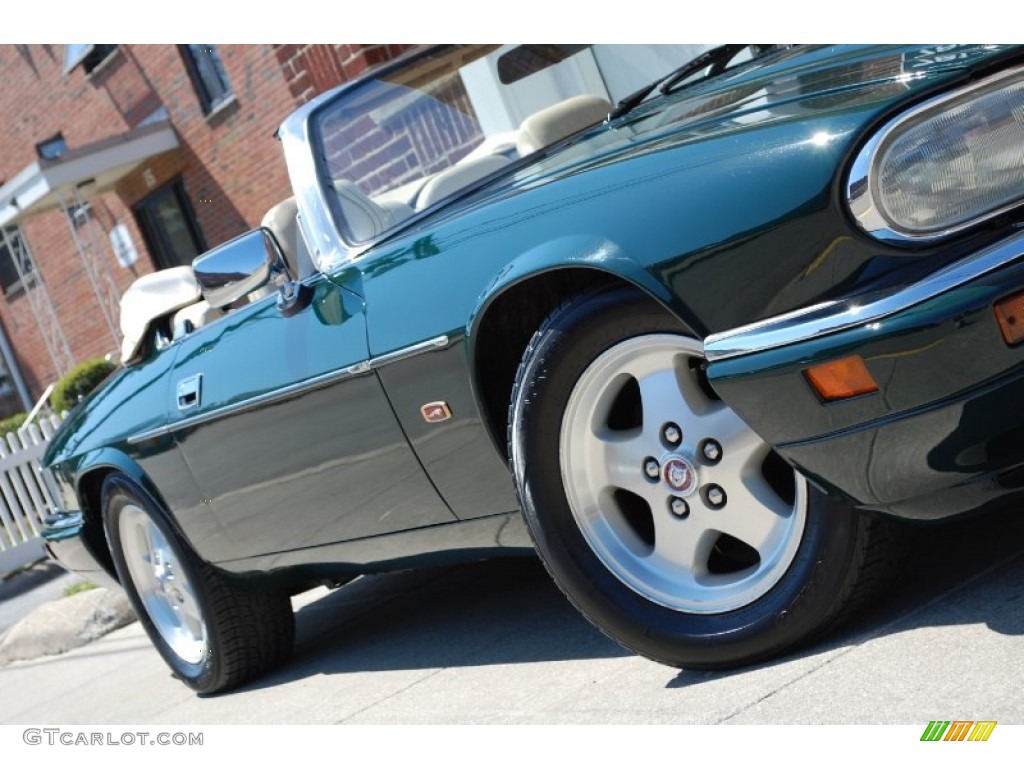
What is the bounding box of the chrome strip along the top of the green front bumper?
[705,233,1024,362]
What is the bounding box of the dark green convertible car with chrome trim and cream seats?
[37,45,1024,692]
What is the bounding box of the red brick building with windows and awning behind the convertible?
[0,45,409,417]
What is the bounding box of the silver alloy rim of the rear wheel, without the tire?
[119,504,208,665]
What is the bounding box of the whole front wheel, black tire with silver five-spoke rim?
[509,290,894,669]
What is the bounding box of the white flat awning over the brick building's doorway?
[0,121,178,226]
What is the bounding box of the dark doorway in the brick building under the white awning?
[133,178,206,269]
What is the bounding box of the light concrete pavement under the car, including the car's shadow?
[0,501,1024,728]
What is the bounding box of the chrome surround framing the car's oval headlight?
[846,67,1024,244]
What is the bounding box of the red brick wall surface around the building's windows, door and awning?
[0,45,410,417]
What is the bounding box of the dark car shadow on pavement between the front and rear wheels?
[234,557,629,690]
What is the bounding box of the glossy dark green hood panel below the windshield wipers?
[490,45,1016,194]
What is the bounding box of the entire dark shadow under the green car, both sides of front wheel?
[237,509,1024,695]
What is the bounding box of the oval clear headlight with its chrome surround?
[847,68,1024,241]
